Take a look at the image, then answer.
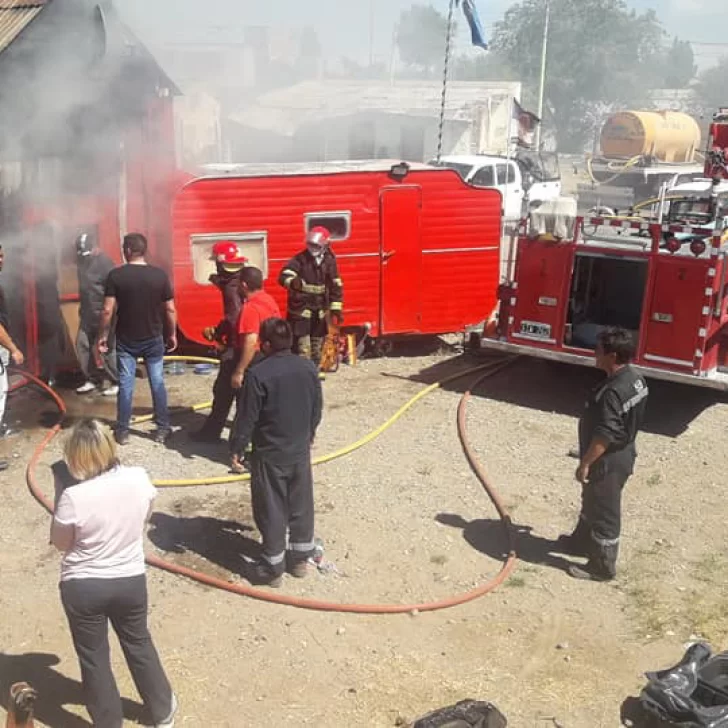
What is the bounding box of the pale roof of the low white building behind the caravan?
[230,81,521,136]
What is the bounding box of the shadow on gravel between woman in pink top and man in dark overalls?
[149,513,261,574]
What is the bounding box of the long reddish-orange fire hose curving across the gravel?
[22,360,516,614]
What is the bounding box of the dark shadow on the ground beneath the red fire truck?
[409,354,723,438]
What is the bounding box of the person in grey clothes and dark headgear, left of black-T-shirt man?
[76,233,119,397]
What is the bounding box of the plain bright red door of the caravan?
[380,187,422,334]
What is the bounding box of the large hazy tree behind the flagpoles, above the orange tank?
[491,0,665,152]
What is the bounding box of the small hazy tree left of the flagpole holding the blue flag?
[397,5,447,73]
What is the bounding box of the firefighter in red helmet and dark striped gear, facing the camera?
[278,227,343,368]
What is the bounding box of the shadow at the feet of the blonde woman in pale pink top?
[0,656,146,728]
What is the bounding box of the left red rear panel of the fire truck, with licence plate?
[510,240,574,344]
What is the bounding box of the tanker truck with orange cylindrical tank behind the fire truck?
[577,111,704,213]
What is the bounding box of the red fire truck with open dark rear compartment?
[482,110,728,390]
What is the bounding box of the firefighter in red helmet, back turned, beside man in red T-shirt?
[191,241,248,443]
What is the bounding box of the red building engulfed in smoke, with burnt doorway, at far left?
[0,0,178,374]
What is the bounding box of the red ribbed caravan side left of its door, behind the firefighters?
[173,173,382,343]
